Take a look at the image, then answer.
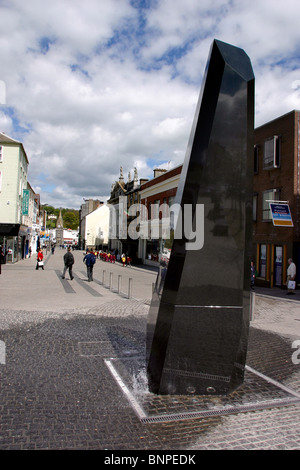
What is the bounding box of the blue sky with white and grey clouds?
[0,0,300,208]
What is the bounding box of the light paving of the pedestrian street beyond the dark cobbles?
[0,248,156,310]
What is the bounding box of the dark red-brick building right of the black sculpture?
[253,110,300,287]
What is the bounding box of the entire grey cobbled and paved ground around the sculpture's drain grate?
[0,250,300,450]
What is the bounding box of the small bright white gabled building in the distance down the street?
[84,204,109,249]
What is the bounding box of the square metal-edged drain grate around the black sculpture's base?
[105,357,300,424]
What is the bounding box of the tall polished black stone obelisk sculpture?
[147,40,254,395]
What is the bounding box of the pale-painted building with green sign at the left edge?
[0,133,29,262]
